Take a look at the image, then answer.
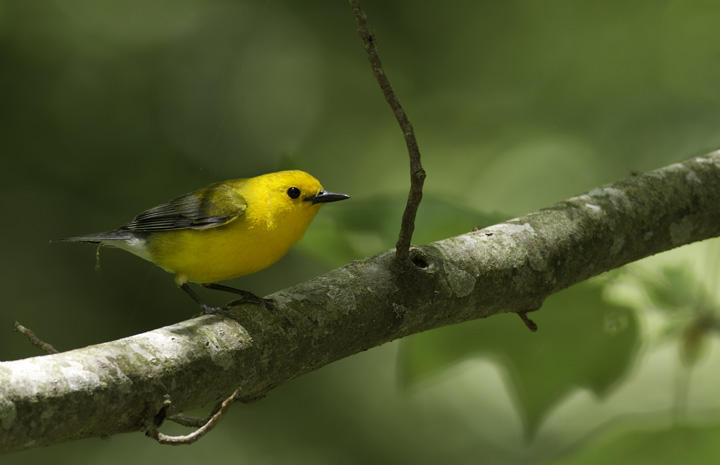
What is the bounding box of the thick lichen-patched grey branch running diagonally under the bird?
[0,152,720,452]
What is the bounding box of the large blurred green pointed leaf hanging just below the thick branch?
[399,283,640,437]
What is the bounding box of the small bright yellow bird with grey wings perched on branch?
[53,170,350,314]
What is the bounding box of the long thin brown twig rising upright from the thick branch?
[350,0,425,269]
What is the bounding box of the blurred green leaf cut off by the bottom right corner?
[549,426,720,465]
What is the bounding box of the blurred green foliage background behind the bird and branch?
[0,0,720,465]
